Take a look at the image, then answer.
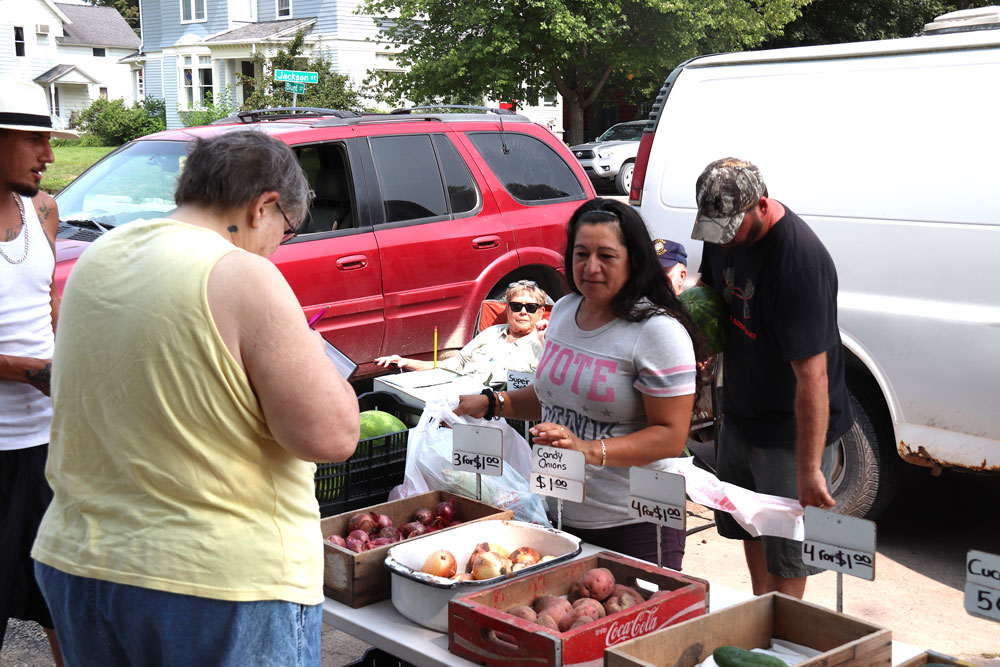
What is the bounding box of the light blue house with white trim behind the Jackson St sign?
[131,0,562,131]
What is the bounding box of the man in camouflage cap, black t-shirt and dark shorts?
[691,158,853,598]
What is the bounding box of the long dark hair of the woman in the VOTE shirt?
[564,197,715,361]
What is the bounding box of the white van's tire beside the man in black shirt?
[831,375,903,520]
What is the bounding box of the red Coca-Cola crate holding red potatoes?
[448,551,708,667]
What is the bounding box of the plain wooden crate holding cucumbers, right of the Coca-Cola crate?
[604,593,892,667]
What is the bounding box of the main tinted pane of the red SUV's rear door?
[371,134,448,222]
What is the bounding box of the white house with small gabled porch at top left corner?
[0,0,140,127]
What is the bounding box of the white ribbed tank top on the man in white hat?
[0,197,55,450]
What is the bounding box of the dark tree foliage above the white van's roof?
[763,0,996,48]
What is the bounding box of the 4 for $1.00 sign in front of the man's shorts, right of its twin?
[802,507,875,581]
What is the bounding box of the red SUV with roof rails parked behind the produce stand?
[56,109,594,376]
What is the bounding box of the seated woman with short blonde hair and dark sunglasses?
[375,280,548,382]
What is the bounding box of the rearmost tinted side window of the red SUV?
[468,132,583,202]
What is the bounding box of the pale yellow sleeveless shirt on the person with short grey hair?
[32,220,323,605]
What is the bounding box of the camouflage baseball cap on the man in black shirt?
[691,157,767,244]
